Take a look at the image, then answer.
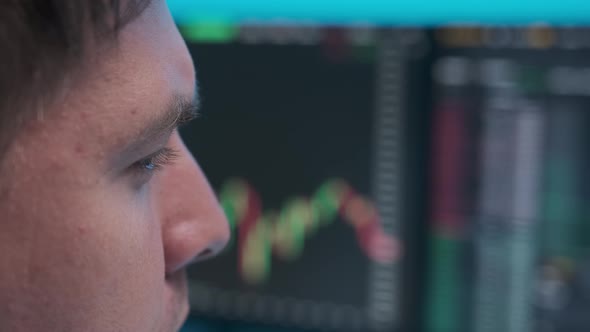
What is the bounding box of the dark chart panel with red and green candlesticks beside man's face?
[181,36,407,330]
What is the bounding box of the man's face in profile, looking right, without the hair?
[0,1,229,332]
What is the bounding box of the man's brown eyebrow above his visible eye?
[135,94,199,142]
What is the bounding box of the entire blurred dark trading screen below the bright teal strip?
[181,24,590,332]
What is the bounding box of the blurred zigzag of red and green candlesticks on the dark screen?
[219,179,400,284]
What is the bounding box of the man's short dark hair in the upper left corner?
[0,0,149,156]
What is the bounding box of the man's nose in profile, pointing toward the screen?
[156,133,230,275]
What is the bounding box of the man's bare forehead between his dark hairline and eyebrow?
[82,1,195,134]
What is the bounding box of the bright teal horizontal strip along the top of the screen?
[168,0,590,25]
